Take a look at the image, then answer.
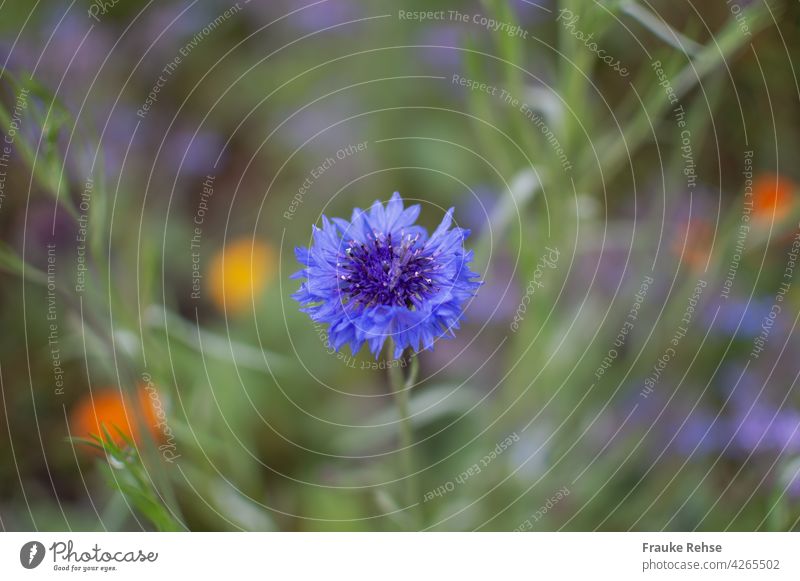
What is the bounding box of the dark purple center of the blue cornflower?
[336,232,440,309]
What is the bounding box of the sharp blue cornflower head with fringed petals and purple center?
[292,192,481,358]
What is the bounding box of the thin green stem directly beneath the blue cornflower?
[386,339,422,530]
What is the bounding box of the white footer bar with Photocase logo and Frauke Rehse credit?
[0,533,800,581]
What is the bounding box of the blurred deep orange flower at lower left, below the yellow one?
[70,385,158,447]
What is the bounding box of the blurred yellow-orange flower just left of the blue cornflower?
[209,238,276,315]
